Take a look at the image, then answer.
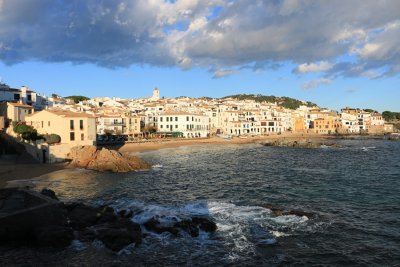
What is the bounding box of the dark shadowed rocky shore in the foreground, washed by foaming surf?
[0,188,217,252]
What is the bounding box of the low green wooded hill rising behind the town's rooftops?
[222,94,317,109]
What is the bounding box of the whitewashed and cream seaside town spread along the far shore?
[0,84,394,162]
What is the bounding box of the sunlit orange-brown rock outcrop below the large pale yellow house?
[68,146,151,172]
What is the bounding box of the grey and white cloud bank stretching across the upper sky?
[0,0,400,77]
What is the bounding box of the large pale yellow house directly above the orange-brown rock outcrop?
[25,109,96,146]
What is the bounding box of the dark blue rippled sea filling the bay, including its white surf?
[0,139,400,266]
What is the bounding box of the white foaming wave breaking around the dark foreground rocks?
[108,199,313,262]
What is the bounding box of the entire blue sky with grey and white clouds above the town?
[0,0,400,112]
